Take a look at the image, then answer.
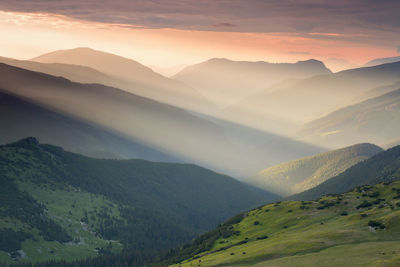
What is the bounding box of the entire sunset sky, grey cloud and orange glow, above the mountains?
[0,0,400,68]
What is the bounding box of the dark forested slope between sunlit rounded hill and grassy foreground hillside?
[290,146,400,200]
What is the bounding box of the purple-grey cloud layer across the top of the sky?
[0,0,400,46]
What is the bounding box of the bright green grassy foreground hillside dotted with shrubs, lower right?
[159,181,400,267]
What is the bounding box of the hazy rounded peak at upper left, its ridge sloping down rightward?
[31,47,215,112]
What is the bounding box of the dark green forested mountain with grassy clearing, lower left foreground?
[0,137,277,263]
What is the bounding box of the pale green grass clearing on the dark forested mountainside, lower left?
[0,180,123,263]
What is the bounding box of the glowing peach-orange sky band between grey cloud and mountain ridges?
[0,11,396,70]
